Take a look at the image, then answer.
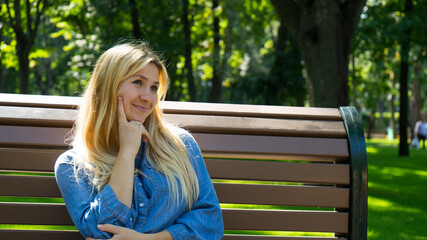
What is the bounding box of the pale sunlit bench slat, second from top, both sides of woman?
[0,106,346,138]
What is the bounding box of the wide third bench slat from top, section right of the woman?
[193,133,349,159]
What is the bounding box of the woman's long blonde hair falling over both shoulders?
[71,43,199,209]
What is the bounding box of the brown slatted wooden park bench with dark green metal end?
[0,94,367,240]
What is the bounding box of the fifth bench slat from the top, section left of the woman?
[0,175,62,198]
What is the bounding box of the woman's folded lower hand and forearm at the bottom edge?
[86,224,172,240]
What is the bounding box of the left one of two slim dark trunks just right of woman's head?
[182,0,196,102]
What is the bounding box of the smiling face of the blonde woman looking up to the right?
[117,63,159,123]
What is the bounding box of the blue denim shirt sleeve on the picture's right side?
[166,133,224,240]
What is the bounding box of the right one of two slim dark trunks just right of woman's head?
[209,0,222,102]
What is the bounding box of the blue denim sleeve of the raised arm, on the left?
[55,152,132,239]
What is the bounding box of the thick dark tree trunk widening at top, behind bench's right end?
[271,0,366,107]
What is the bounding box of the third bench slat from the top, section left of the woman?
[0,125,70,149]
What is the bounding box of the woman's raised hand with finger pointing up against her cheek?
[117,97,150,157]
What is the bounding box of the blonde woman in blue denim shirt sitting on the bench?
[55,44,223,240]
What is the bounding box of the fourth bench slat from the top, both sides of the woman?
[0,148,350,185]
